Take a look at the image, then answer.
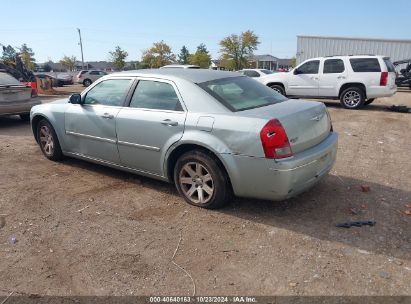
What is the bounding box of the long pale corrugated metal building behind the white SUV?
[296,35,411,64]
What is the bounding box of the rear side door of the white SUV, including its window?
[319,58,347,97]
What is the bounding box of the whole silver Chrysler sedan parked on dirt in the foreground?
[31,69,337,208]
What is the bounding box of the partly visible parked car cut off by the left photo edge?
[0,72,40,121]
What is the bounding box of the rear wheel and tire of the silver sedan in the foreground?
[174,150,232,209]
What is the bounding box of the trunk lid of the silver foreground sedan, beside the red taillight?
[238,99,331,154]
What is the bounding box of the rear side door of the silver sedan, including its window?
[117,78,186,175]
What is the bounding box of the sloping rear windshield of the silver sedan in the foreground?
[198,76,287,112]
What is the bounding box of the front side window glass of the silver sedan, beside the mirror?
[84,79,132,106]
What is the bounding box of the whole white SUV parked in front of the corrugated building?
[256,55,397,109]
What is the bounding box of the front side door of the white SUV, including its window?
[287,60,320,96]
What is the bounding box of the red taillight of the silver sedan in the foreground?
[260,119,293,158]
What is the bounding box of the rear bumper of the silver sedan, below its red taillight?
[221,132,338,201]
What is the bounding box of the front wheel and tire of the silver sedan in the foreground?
[37,119,63,161]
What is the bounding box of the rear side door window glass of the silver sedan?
[130,80,183,111]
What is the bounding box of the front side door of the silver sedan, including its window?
[65,79,132,164]
